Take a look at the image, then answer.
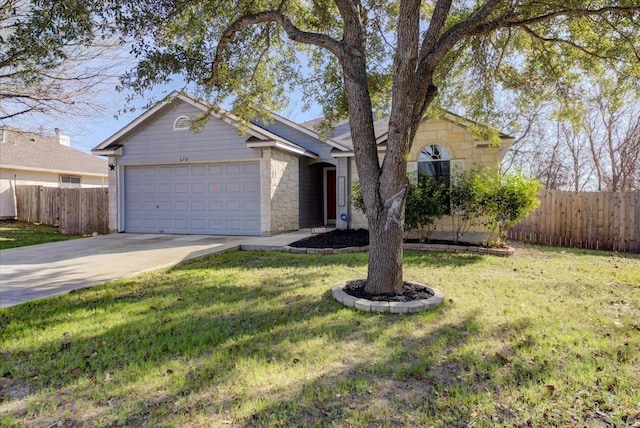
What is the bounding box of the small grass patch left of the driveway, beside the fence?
[0,220,81,250]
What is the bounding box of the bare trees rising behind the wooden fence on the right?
[505,81,640,192]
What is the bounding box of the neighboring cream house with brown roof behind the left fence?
[0,126,108,218]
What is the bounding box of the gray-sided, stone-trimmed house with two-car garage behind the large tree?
[92,92,512,236]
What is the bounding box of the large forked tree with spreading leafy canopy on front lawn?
[46,0,640,293]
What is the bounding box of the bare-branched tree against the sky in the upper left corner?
[0,0,124,120]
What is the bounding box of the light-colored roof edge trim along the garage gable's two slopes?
[91,91,318,159]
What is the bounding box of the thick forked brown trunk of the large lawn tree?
[343,0,422,294]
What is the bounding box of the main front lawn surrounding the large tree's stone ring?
[0,247,640,427]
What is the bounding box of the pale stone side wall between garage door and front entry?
[261,148,299,235]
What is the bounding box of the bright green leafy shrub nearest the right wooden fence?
[475,168,542,244]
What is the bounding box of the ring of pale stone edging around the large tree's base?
[331,280,444,314]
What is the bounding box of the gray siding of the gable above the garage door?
[119,101,260,165]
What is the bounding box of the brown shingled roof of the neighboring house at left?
[0,127,108,177]
